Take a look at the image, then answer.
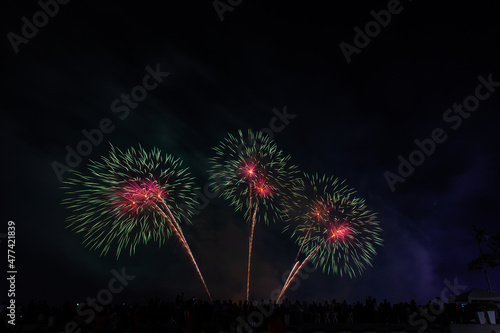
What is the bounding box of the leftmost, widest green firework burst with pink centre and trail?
[62,146,211,299]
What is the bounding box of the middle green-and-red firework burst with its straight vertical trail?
[209,130,303,300]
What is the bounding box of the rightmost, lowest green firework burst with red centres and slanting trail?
[278,174,382,300]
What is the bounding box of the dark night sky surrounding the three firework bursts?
[0,0,500,303]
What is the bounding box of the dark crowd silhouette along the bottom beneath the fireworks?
[1,294,498,333]
